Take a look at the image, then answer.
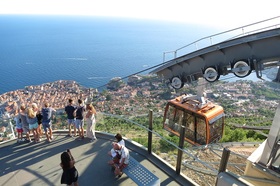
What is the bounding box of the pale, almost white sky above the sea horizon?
[0,0,280,28]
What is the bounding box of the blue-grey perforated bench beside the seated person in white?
[123,156,160,186]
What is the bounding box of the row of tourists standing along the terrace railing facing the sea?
[14,99,96,143]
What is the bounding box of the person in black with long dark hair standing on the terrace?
[60,149,79,186]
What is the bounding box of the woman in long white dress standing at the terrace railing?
[86,103,96,142]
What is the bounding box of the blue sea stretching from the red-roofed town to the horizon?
[0,15,223,94]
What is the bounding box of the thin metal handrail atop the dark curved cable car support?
[163,16,280,63]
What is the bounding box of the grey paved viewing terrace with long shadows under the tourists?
[0,132,193,186]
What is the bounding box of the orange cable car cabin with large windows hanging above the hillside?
[163,95,225,145]
